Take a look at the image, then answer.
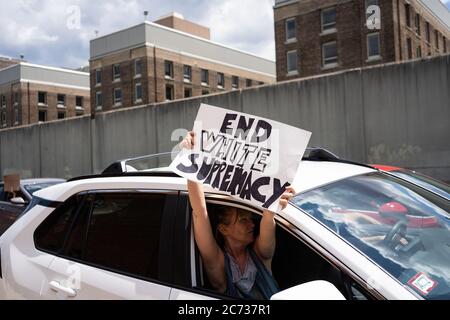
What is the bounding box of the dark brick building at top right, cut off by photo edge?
[274,0,450,81]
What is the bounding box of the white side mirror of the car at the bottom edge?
[270,280,345,300]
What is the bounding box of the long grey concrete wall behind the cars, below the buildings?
[0,56,450,181]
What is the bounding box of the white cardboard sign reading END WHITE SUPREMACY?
[170,104,311,212]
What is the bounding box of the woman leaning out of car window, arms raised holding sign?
[181,132,295,299]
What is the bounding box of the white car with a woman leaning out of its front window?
[0,152,450,300]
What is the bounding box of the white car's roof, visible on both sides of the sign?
[35,161,377,201]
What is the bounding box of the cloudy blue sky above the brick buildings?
[0,0,450,68]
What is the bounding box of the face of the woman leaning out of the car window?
[224,208,255,245]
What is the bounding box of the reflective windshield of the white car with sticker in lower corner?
[292,172,450,299]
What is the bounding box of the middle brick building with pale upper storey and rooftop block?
[90,13,275,113]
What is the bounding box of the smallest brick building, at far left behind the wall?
[0,62,90,129]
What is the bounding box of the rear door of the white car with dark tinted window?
[36,190,178,299]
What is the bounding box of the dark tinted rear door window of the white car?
[70,192,166,279]
